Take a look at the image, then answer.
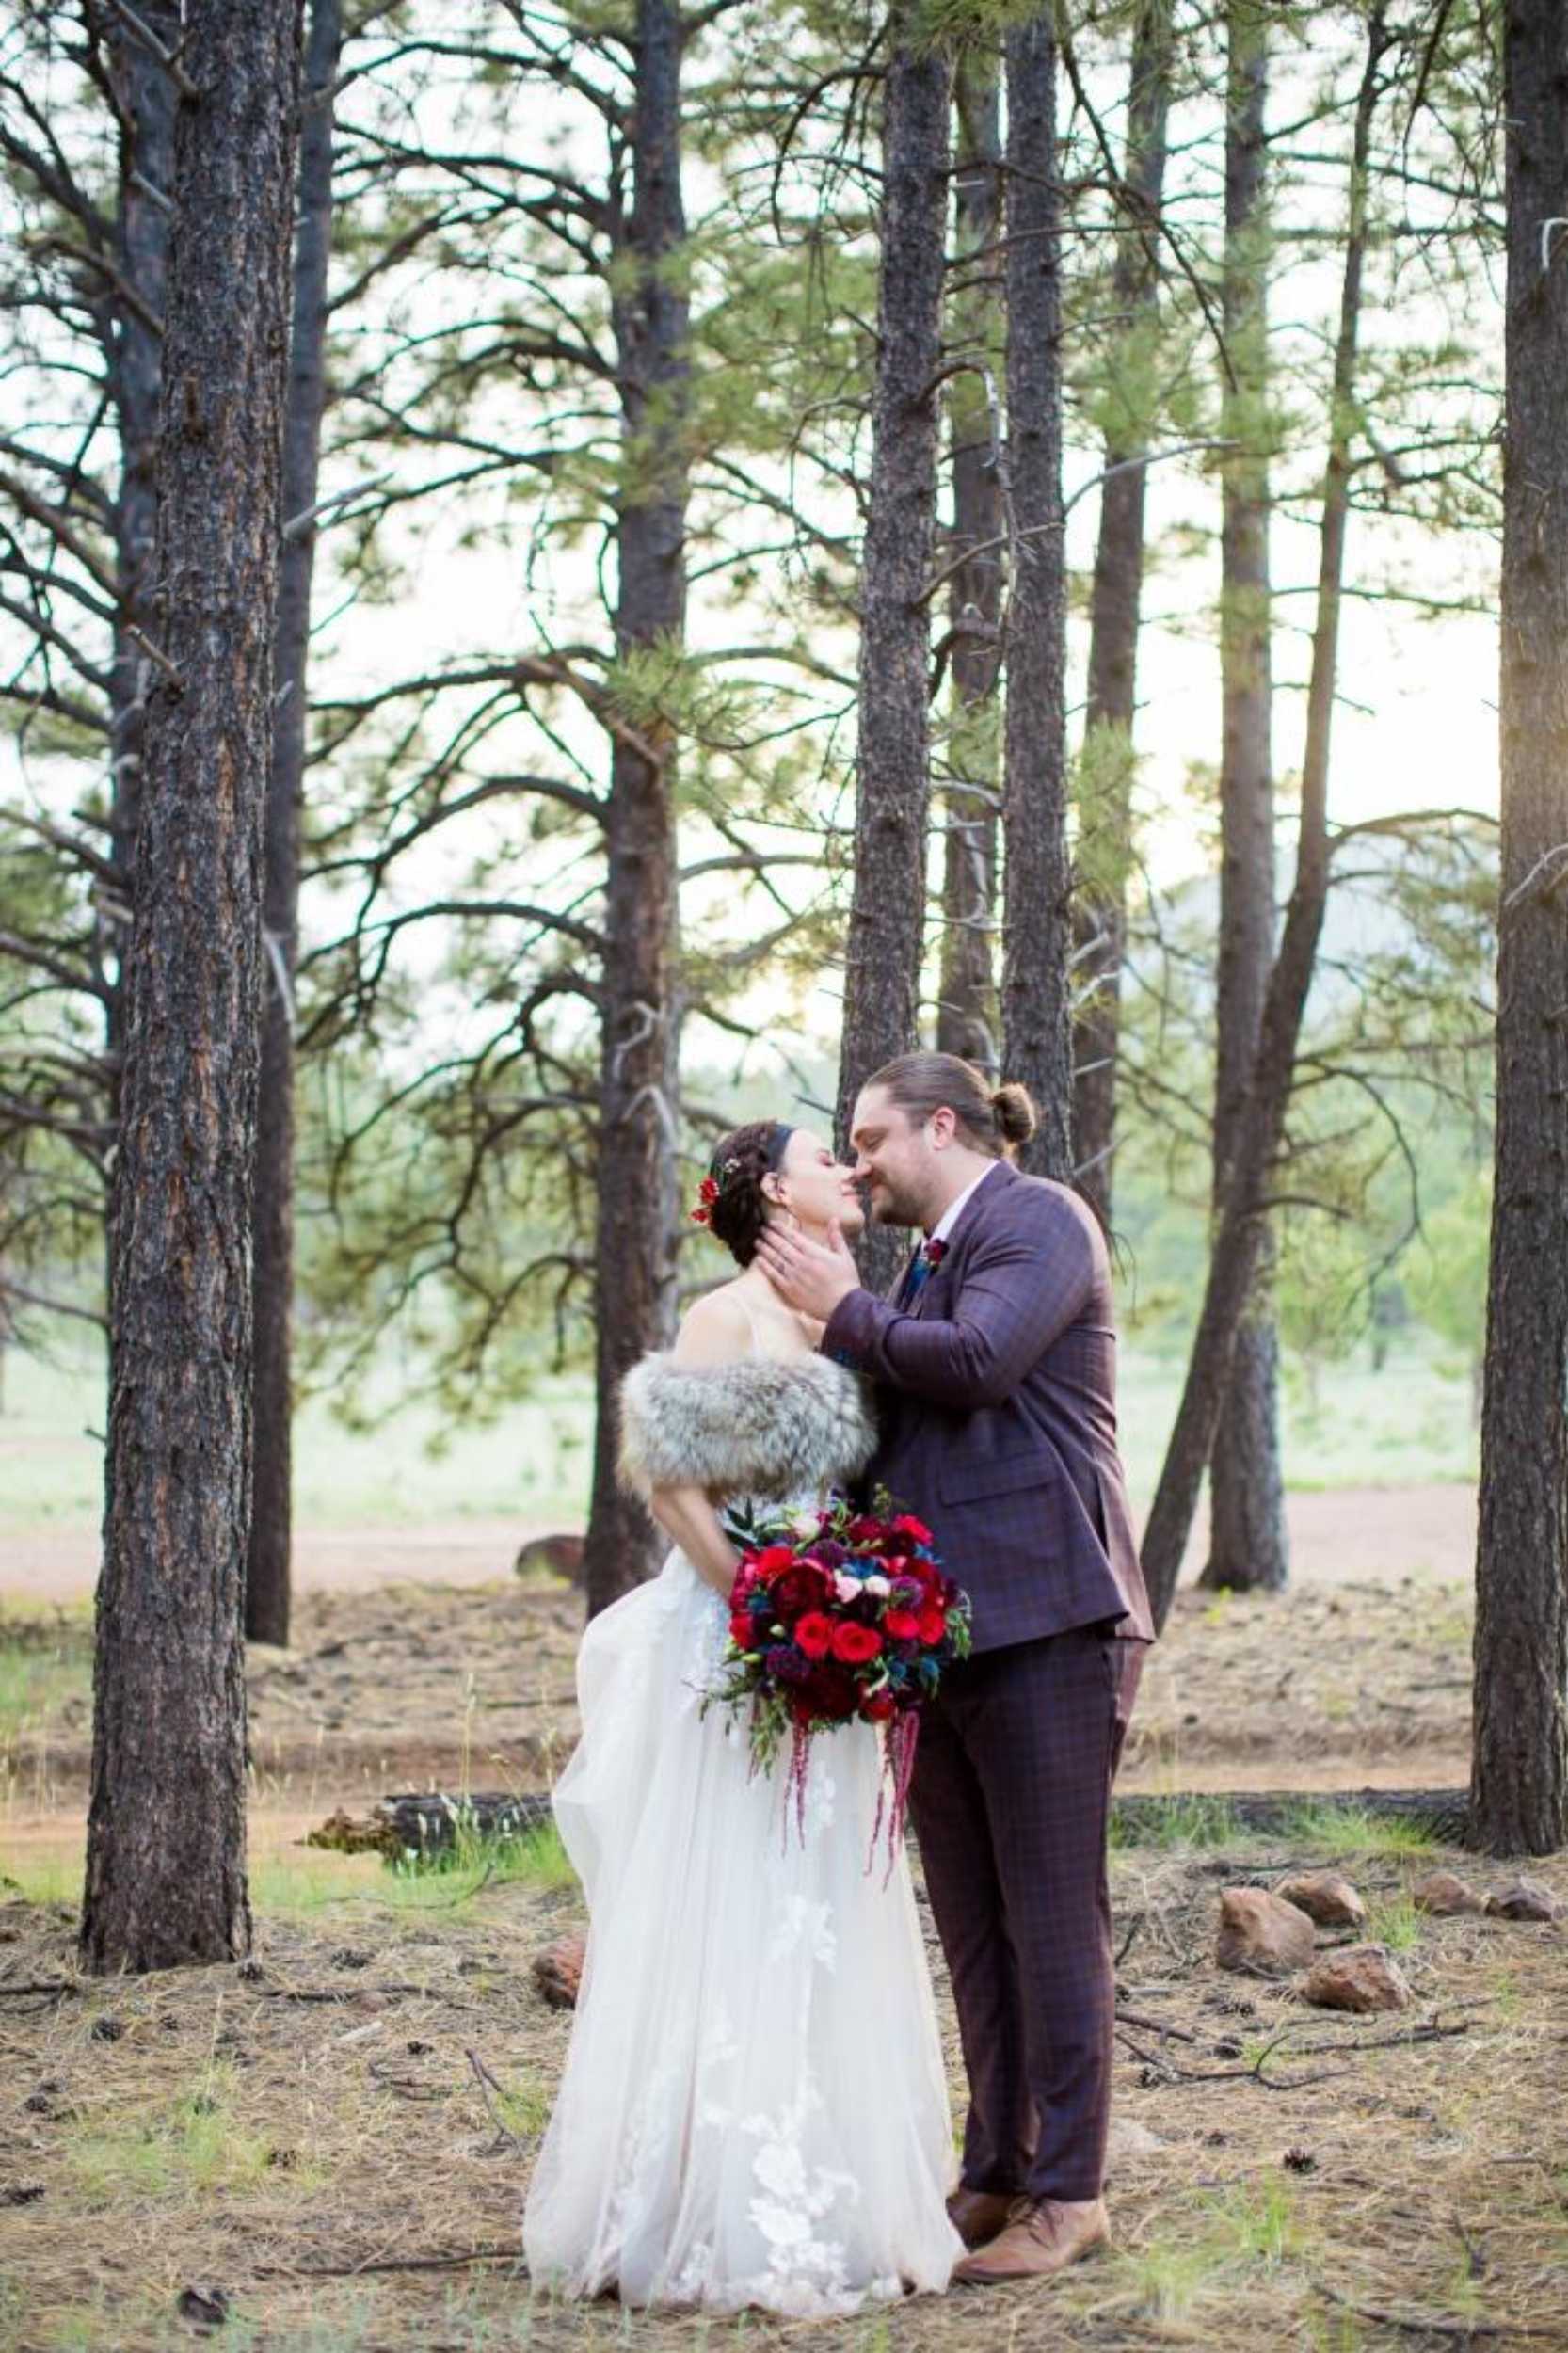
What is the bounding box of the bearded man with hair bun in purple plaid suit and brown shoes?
[758,1054,1154,2281]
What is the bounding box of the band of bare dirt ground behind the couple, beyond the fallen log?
[0,1525,1471,1843]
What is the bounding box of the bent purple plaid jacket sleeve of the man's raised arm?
[822,1203,1095,1407]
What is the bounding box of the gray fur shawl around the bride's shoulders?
[619,1351,876,1499]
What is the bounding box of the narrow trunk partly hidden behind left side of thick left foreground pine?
[97,0,179,1125]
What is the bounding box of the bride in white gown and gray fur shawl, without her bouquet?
[522,1120,963,2318]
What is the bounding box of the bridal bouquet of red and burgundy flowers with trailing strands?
[704,1490,970,1849]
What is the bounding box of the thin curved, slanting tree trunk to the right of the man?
[1142,8,1389,1626]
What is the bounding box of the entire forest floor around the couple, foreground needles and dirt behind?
[0,1490,1568,2353]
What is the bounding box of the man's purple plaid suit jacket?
[822,1160,1154,1650]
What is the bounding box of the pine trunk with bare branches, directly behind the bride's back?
[586,0,687,1612]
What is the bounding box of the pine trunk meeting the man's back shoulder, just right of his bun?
[1074,0,1170,1228]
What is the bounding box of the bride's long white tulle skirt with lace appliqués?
[522,1360,963,2318]
